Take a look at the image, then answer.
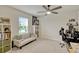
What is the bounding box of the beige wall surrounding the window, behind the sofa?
[0,6,32,37]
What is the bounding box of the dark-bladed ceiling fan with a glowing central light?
[38,5,62,15]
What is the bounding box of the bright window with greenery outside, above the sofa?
[19,17,28,34]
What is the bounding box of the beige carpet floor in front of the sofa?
[9,39,68,53]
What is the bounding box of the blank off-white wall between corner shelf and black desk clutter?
[39,12,78,41]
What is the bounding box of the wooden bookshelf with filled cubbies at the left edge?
[0,17,11,53]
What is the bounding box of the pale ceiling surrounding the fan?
[10,5,79,16]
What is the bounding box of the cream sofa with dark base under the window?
[13,34,37,49]
